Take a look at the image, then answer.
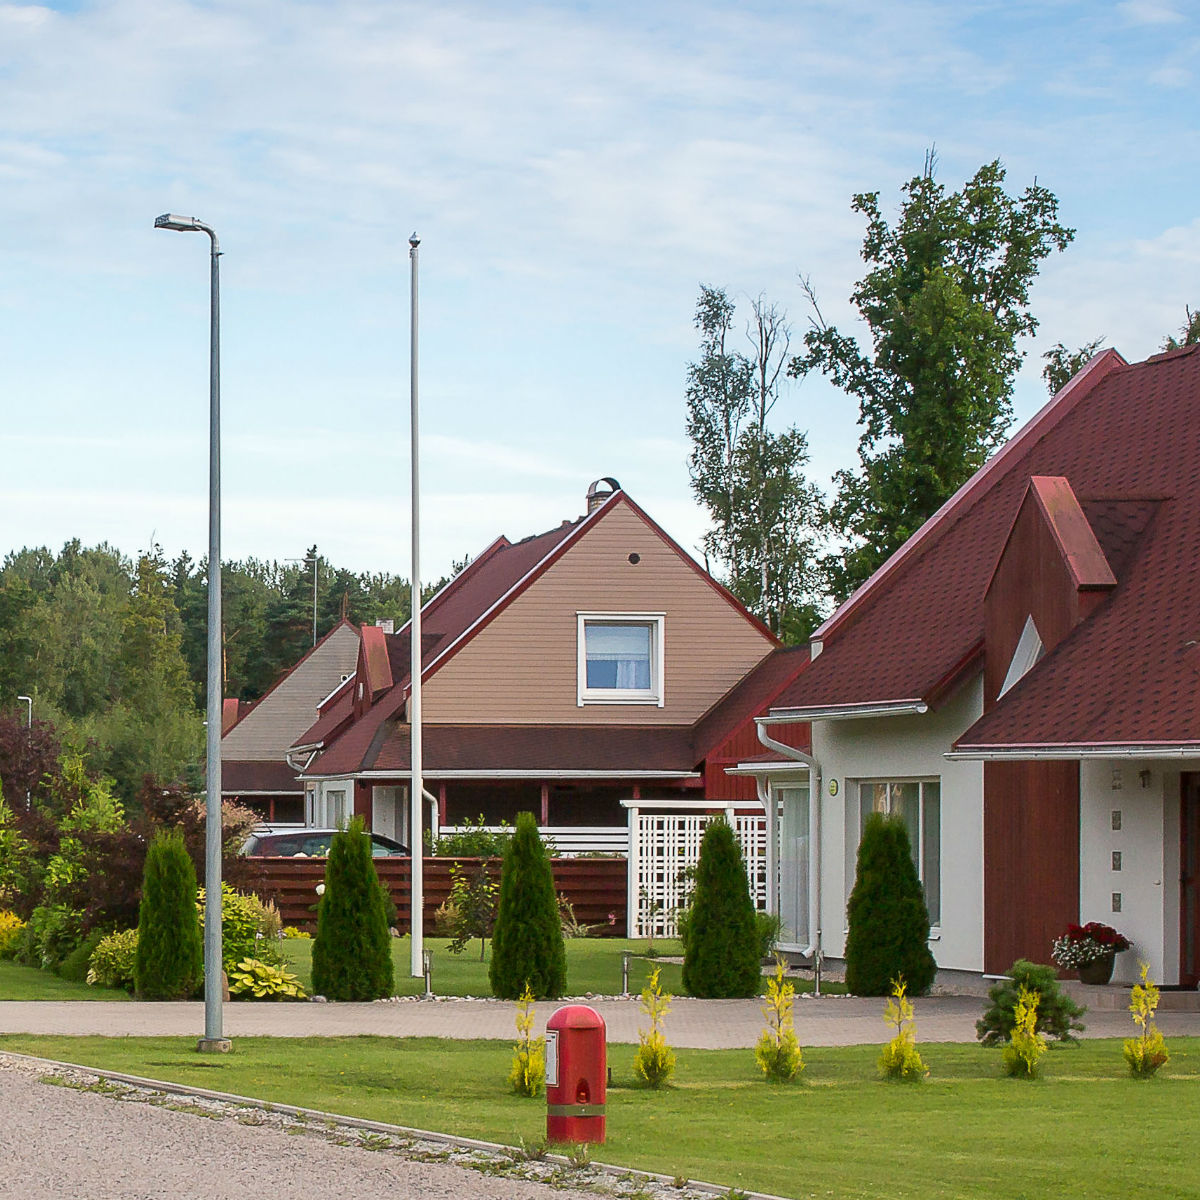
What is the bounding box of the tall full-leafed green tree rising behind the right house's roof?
[790,151,1074,596]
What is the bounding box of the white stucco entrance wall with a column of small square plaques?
[1079,761,1180,983]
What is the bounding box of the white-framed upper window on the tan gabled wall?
[576,612,665,708]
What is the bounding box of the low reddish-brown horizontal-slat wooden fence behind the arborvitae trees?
[254,856,628,937]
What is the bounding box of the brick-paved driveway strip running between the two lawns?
[0,996,1200,1049]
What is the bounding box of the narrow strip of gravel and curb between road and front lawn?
[0,1050,786,1200]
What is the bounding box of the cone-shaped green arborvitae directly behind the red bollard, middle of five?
[487,812,566,1000]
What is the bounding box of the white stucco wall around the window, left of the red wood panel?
[812,676,983,971]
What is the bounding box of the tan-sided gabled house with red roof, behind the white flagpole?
[290,480,809,902]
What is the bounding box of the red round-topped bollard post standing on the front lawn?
[546,1004,608,1144]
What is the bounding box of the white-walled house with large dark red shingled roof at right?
[743,346,1200,986]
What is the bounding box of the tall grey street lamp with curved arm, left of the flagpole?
[154,212,229,1052]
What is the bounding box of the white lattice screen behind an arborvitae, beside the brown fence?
[630,812,767,937]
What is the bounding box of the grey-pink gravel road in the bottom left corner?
[0,1064,614,1200]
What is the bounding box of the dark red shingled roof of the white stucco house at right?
[776,347,1200,749]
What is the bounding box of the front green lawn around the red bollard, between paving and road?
[0,1021,1200,1200]
